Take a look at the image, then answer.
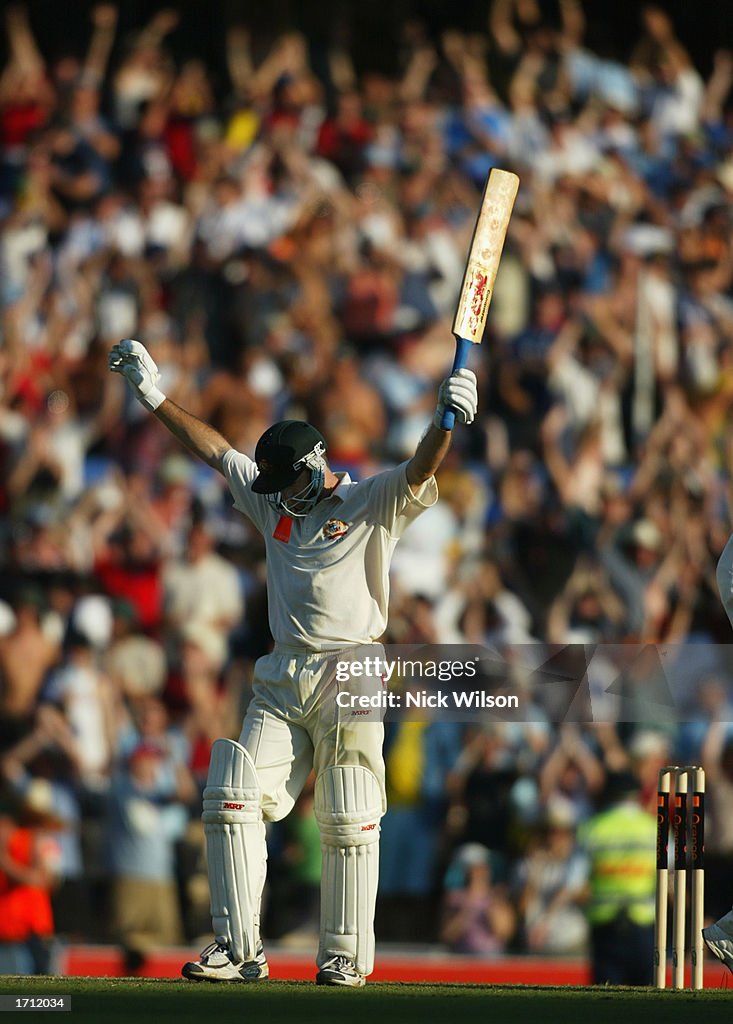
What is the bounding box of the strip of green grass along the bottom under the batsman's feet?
[0,978,733,1024]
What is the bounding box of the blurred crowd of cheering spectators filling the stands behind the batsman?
[0,0,733,970]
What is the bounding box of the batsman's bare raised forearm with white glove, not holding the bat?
[110,338,231,473]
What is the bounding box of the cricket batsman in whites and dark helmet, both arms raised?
[110,339,478,986]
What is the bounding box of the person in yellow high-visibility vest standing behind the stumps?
[578,772,656,985]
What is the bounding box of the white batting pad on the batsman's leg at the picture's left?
[202,739,267,962]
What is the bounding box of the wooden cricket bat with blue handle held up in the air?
[440,167,519,430]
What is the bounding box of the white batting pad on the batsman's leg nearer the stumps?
[314,765,382,975]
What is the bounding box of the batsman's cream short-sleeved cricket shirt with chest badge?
[222,449,438,650]
